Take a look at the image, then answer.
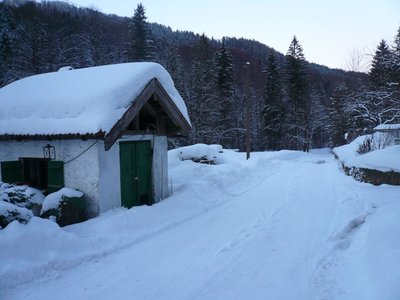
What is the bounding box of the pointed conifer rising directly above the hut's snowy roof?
[127,3,156,61]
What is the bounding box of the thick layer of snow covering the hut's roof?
[0,62,190,135]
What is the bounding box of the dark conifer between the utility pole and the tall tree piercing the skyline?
[262,51,285,150]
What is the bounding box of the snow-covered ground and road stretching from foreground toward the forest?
[0,150,400,300]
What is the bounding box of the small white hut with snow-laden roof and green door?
[0,63,191,216]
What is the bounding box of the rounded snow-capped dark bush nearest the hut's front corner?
[40,188,85,226]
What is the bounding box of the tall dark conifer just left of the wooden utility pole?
[215,39,235,147]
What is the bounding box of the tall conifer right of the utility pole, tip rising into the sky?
[284,36,310,151]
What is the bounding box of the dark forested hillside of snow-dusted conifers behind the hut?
[0,1,400,151]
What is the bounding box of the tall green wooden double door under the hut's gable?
[119,141,153,208]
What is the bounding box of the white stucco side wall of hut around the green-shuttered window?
[0,140,99,216]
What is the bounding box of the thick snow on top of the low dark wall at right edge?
[333,135,400,172]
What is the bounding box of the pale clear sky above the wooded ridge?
[49,0,400,68]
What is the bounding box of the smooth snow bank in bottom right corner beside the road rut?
[337,203,400,300]
